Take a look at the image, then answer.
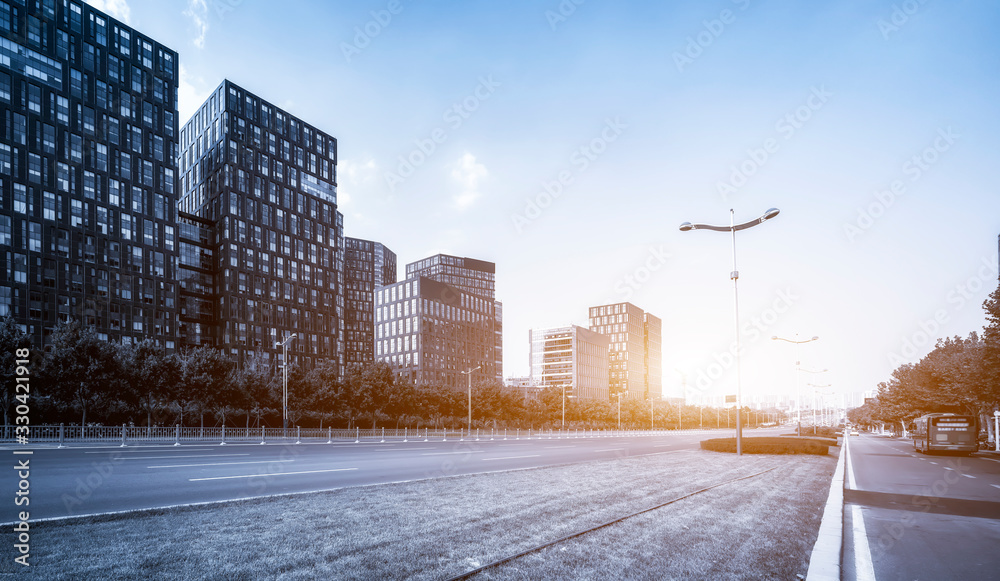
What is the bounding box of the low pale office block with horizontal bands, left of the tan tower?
[530,325,609,401]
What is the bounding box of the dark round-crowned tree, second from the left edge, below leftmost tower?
[39,320,119,426]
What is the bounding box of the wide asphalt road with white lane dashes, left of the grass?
[0,430,763,523]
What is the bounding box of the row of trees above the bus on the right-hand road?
[847,280,1000,431]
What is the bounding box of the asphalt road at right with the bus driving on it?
[843,434,1000,581]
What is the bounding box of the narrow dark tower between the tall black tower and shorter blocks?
[344,238,396,367]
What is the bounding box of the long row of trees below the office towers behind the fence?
[0,318,779,429]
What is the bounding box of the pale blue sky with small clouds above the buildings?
[91,0,1000,402]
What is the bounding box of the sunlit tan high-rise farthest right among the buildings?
[590,303,663,399]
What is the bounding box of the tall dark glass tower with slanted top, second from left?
[179,81,347,373]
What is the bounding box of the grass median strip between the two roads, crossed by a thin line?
[0,448,836,580]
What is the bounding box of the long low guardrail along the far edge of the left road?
[0,425,711,447]
